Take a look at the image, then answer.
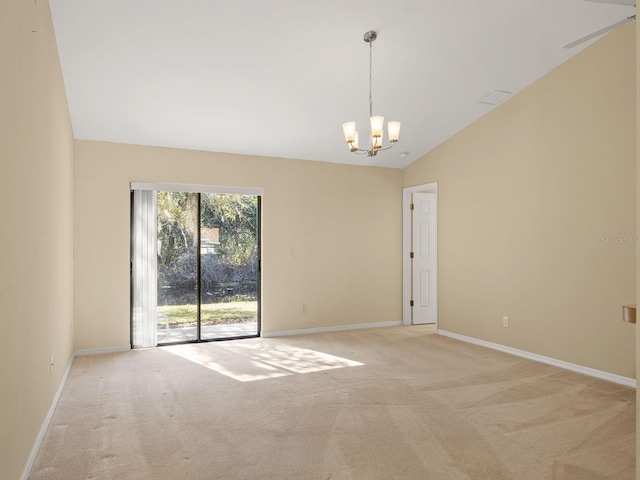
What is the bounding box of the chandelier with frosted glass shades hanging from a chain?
[342,30,400,157]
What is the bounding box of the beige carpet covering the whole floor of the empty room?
[31,326,635,480]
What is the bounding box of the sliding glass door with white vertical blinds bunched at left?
[132,184,260,347]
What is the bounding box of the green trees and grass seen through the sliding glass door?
[157,191,258,328]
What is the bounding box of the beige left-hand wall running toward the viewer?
[0,0,73,479]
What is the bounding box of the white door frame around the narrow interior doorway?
[402,182,438,330]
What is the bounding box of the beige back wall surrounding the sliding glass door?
[75,141,402,348]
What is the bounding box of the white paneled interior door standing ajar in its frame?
[411,193,438,325]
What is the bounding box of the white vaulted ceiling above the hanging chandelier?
[50,0,635,168]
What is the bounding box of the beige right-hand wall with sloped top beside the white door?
[404,24,636,378]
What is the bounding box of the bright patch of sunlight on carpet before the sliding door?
[161,339,364,382]
